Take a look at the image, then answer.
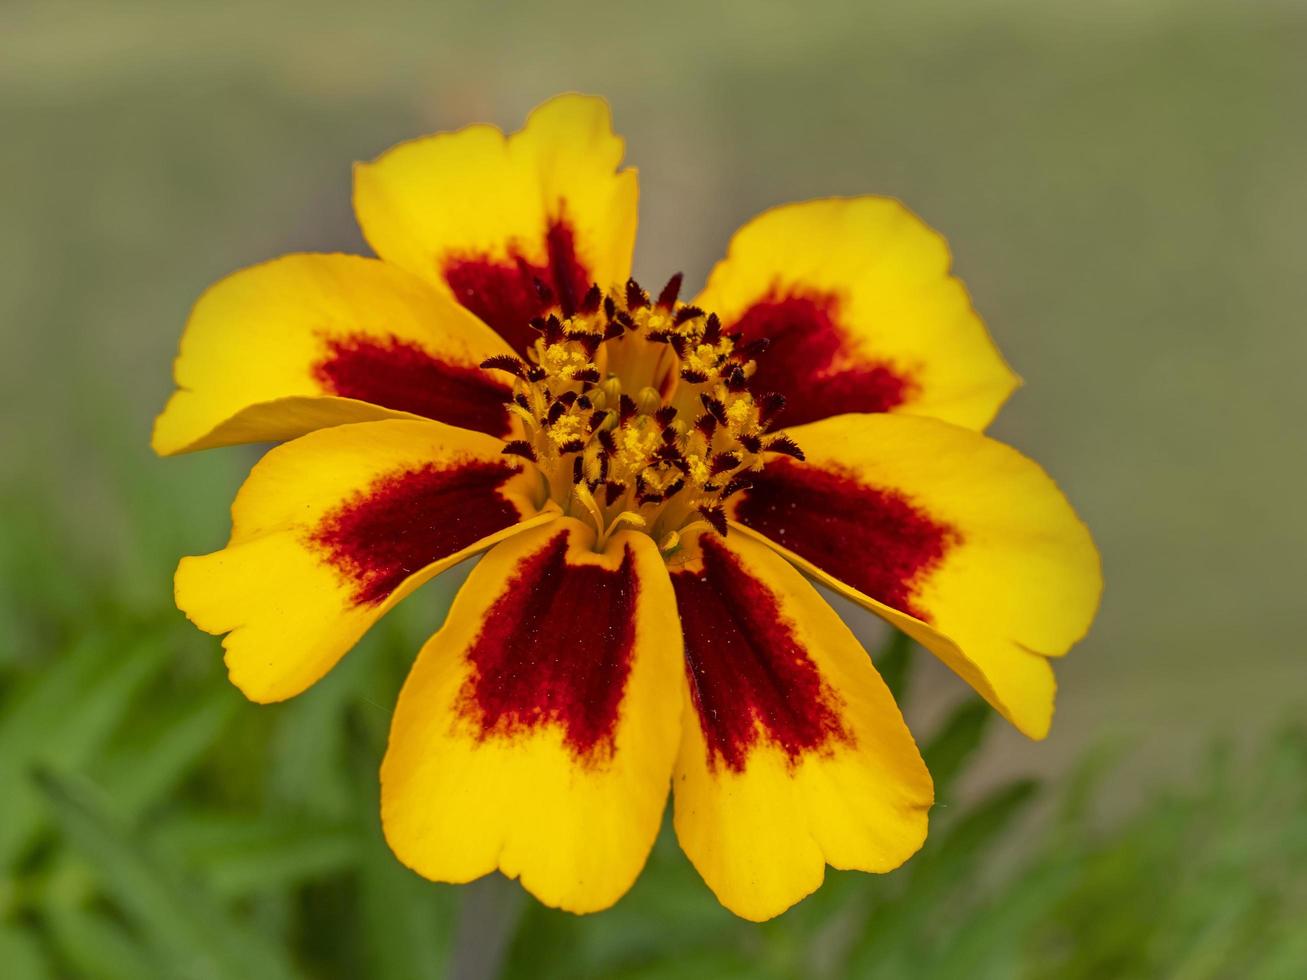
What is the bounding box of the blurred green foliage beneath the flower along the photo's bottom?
[0,465,1307,980]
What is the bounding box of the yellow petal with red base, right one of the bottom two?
[672,534,932,920]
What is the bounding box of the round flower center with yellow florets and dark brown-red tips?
[481,274,802,554]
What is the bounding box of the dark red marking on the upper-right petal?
[731,291,918,426]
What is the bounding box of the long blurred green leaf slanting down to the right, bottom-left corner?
[37,770,293,980]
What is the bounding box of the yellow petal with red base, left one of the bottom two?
[382,517,681,912]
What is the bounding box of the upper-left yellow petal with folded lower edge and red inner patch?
[154,255,511,456]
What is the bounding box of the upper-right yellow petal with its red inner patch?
[695,197,1019,429]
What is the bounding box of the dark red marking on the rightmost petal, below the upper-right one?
[735,459,962,622]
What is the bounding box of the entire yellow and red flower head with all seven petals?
[154,95,1100,919]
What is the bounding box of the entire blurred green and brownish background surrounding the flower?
[0,0,1307,980]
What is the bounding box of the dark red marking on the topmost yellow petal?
[442,218,591,354]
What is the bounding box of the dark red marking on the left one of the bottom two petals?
[461,532,639,760]
